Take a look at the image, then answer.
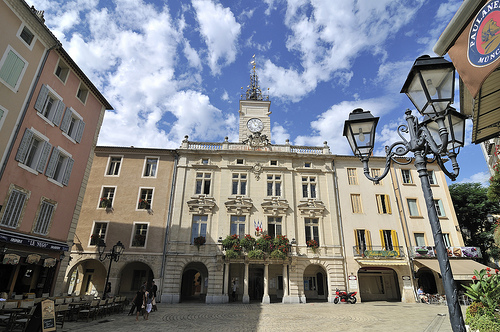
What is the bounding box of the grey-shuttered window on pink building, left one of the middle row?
[15,128,52,173]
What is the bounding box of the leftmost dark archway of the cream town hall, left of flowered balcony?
[181,262,208,302]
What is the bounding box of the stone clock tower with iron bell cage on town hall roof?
[239,55,271,146]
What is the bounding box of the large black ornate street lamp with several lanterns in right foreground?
[344,55,465,332]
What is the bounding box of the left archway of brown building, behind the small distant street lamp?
[68,259,106,296]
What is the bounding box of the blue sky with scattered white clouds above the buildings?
[26,0,489,184]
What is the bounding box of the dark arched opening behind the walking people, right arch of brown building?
[119,262,154,298]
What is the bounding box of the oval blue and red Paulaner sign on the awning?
[467,0,500,67]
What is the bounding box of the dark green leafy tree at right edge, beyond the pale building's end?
[449,183,500,264]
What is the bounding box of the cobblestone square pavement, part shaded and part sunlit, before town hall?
[58,302,465,332]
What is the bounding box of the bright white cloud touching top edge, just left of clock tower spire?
[192,0,241,74]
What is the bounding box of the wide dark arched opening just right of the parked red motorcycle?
[358,267,401,302]
